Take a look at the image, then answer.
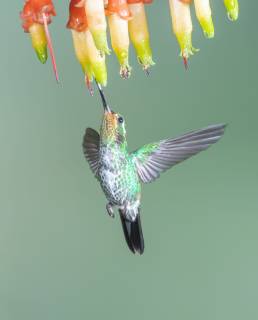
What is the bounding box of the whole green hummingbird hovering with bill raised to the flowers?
[83,85,225,254]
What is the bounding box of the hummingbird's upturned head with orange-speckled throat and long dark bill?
[95,85,126,146]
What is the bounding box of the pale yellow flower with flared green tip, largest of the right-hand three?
[169,0,198,67]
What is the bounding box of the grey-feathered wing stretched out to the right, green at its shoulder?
[132,124,226,183]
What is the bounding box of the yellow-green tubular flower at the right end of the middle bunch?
[127,0,155,74]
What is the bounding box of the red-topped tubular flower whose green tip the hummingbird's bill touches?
[67,0,107,89]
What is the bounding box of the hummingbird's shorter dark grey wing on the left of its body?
[82,128,100,175]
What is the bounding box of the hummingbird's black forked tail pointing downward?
[119,209,144,254]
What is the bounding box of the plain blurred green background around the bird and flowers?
[0,0,258,320]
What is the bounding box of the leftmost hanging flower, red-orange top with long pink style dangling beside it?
[20,0,59,81]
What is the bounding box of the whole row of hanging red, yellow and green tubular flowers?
[21,0,239,88]
